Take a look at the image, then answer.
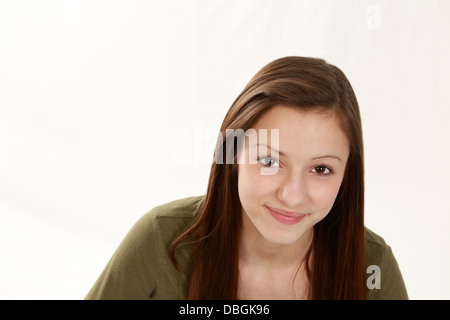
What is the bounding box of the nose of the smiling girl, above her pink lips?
[278,173,307,208]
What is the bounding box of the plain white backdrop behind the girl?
[0,0,450,299]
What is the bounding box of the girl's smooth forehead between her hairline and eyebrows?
[252,105,349,156]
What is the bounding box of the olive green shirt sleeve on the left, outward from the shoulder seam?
[85,211,159,300]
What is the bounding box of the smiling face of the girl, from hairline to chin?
[238,106,349,245]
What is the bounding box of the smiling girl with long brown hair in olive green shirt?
[86,57,408,299]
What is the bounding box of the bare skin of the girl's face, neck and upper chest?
[238,105,349,299]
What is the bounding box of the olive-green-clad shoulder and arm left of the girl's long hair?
[86,196,204,299]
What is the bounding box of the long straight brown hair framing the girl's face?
[169,57,367,299]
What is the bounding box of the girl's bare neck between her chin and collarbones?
[239,213,313,269]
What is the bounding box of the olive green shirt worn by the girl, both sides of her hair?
[85,196,408,300]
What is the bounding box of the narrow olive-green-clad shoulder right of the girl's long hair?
[365,228,408,300]
